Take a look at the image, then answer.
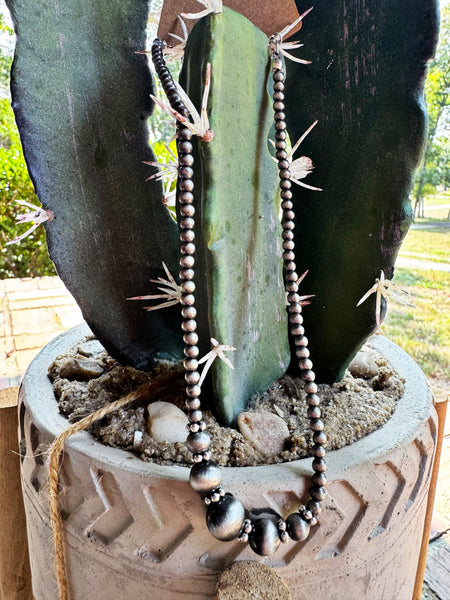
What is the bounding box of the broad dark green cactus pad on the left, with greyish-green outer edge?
[7,0,183,368]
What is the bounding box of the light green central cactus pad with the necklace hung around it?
[182,7,289,423]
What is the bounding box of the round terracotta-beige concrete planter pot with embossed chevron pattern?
[20,327,436,600]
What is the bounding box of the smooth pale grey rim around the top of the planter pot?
[21,323,432,483]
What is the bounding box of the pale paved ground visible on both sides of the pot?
[0,277,450,600]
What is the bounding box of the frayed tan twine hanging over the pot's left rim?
[48,382,156,600]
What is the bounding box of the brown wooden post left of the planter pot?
[0,387,33,600]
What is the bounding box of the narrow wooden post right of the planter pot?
[413,401,447,600]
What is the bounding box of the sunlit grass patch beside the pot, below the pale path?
[383,268,450,388]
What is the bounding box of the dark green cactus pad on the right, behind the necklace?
[286,0,437,382]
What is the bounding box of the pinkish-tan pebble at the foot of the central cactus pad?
[237,412,289,455]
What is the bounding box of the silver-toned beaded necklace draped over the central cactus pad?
[152,34,326,556]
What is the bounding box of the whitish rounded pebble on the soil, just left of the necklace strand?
[147,402,189,443]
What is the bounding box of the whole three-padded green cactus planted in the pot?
[7,0,436,423]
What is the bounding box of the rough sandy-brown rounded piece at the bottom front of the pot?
[214,561,292,600]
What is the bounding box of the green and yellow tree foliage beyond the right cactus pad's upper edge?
[414,4,450,217]
